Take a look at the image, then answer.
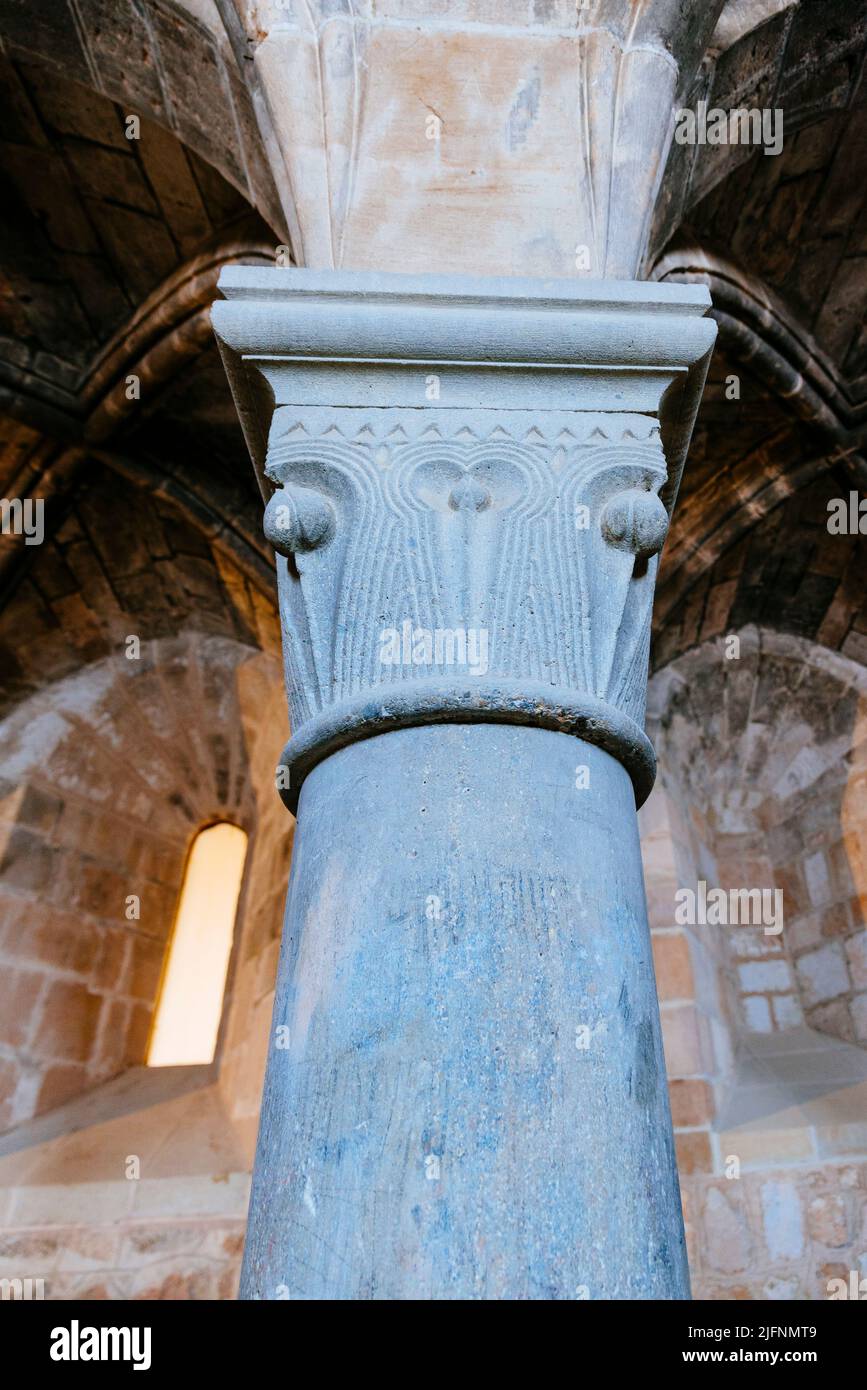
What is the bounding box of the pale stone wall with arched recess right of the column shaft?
[641,628,867,1300]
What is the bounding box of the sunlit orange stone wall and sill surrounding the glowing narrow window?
[0,536,293,1298]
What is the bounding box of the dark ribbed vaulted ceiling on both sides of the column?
[0,0,867,672]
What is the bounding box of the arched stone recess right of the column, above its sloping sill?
[654,628,867,1043]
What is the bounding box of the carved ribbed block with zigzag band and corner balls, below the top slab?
[265,407,667,728]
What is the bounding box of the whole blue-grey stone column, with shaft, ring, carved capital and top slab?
[214,267,714,1298]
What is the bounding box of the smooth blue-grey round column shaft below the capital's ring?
[242,724,689,1300]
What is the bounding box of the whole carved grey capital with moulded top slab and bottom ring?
[214,268,716,810]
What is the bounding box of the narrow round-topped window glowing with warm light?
[147,821,247,1066]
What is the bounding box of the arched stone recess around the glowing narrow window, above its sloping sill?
[0,630,290,1129]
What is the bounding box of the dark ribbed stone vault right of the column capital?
[653,0,867,660]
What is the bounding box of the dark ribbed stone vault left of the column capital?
[0,42,276,614]
